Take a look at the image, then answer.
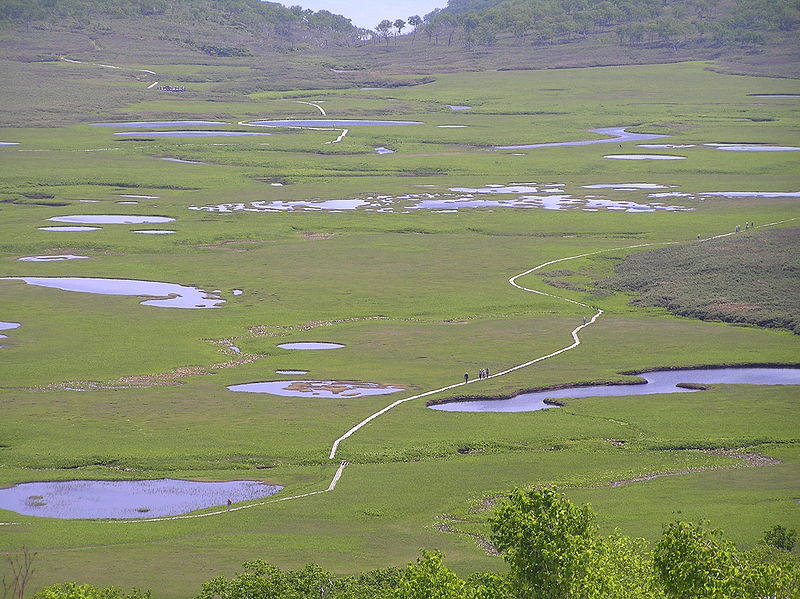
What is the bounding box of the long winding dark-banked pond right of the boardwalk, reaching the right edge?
[429,368,800,412]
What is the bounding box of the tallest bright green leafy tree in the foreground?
[489,487,595,599]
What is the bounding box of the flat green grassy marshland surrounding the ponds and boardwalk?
[0,63,800,598]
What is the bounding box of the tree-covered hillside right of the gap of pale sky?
[425,0,800,47]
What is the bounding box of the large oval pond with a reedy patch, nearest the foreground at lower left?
[0,478,283,519]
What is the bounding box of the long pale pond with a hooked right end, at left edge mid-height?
[0,277,225,308]
